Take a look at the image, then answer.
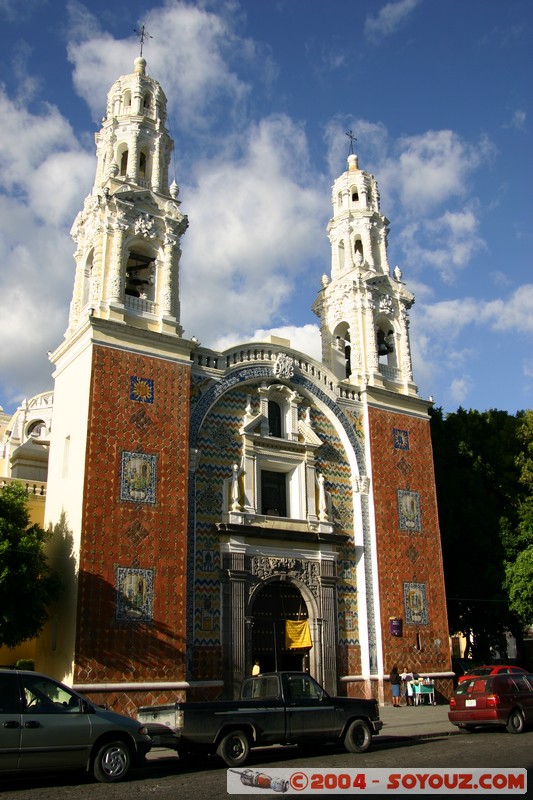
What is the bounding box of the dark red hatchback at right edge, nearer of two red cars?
[448,673,533,733]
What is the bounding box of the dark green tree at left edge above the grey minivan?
[0,481,62,647]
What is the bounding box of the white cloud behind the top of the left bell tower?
[68,0,260,128]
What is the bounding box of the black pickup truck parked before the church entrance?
[137,672,383,767]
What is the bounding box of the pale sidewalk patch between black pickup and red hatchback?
[379,704,459,739]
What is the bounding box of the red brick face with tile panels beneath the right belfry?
[369,408,450,687]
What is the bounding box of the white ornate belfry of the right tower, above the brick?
[313,153,418,396]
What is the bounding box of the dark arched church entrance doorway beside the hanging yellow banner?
[251,581,311,672]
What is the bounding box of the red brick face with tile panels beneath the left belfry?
[74,346,190,710]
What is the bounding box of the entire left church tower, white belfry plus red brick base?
[39,57,193,692]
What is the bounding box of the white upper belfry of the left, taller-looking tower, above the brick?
[66,57,188,338]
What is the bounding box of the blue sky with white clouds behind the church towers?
[0,0,533,414]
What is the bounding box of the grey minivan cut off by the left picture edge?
[0,669,152,783]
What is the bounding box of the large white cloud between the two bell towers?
[181,115,328,344]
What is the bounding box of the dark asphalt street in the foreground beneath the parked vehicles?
[0,730,533,800]
